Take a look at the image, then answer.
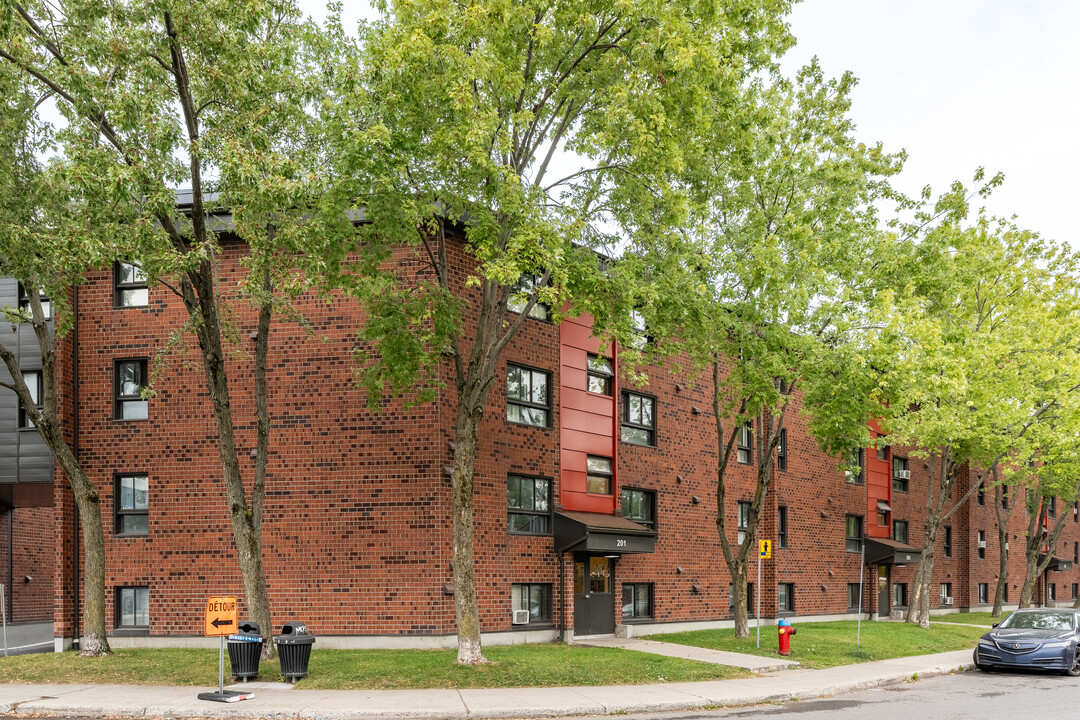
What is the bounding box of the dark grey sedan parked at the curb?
[975,608,1080,676]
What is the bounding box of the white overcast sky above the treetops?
[315,0,1080,249]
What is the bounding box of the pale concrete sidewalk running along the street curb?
[0,650,971,720]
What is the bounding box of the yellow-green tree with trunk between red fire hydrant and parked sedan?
[872,195,1077,627]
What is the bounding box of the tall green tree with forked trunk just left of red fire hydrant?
[596,63,902,637]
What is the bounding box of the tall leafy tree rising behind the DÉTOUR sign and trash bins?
[0,0,352,655]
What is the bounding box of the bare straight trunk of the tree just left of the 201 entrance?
[450,397,487,665]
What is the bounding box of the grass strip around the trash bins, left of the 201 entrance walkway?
[0,643,751,690]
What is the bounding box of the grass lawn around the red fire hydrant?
[651,621,986,668]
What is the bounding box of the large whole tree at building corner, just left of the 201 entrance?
[334,0,789,664]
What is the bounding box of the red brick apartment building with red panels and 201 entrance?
[0,234,1080,648]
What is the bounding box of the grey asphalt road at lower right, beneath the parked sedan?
[570,671,1080,720]
